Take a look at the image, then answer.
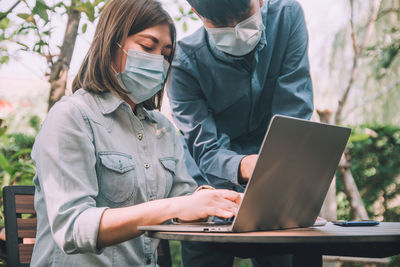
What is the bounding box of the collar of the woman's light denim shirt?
[96,92,156,122]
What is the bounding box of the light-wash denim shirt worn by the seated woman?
[31,89,197,266]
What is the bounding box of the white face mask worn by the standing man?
[205,7,265,56]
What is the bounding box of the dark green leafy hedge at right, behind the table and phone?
[337,126,400,221]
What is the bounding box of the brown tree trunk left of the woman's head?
[48,2,81,110]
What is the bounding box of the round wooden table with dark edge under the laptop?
[146,223,400,267]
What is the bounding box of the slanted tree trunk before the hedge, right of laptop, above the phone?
[339,155,368,220]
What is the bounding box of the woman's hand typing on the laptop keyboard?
[174,189,241,221]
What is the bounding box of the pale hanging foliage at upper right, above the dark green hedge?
[327,0,400,124]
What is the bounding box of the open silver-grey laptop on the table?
[138,115,351,232]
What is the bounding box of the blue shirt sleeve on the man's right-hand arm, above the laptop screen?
[272,1,313,119]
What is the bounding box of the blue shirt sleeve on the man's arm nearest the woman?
[167,61,244,188]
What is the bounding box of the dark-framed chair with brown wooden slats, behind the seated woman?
[3,185,172,267]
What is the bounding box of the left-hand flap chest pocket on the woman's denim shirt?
[99,151,138,205]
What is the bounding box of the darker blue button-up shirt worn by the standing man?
[167,0,313,193]
